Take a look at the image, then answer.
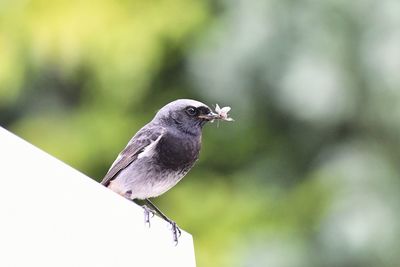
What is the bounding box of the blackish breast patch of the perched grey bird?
[156,133,201,171]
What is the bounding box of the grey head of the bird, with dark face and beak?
[154,99,218,134]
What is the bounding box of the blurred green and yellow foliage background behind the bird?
[0,0,400,267]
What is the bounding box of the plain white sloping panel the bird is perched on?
[0,127,195,267]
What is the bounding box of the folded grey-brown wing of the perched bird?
[101,125,165,186]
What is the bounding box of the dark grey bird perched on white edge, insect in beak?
[101,99,220,242]
